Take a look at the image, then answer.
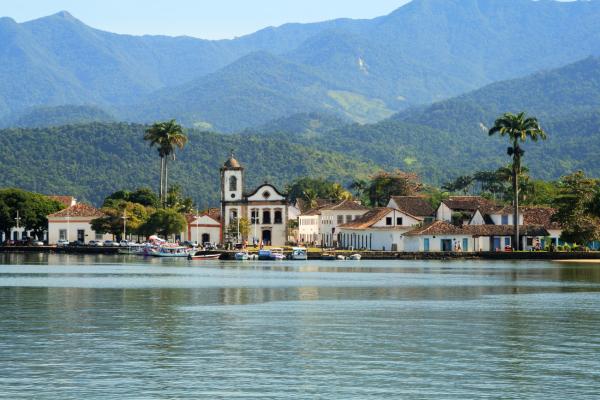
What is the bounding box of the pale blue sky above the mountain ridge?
[0,0,409,39]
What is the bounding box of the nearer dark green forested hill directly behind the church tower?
[0,123,376,208]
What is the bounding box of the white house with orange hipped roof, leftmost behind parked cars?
[48,203,112,244]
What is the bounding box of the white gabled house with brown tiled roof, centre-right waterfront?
[337,207,422,251]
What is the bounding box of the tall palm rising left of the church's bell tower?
[144,119,188,206]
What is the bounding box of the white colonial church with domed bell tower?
[221,153,289,246]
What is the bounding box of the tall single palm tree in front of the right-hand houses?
[488,112,546,250]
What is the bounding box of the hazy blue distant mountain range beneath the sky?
[0,0,600,131]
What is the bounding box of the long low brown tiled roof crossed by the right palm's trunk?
[406,221,549,236]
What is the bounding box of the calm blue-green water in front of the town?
[0,254,600,400]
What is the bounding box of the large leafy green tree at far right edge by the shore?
[553,171,600,244]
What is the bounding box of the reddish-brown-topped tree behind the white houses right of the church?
[367,170,423,207]
